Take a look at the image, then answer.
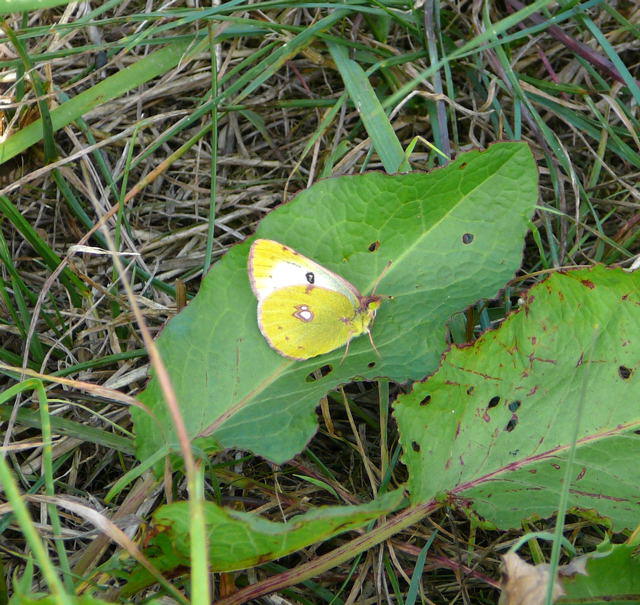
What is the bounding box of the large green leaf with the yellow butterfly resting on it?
[132,143,537,462]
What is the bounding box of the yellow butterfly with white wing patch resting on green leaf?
[248,239,383,360]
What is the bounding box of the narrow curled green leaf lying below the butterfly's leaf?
[125,490,403,596]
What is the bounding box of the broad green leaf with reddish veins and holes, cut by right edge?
[395,266,640,528]
